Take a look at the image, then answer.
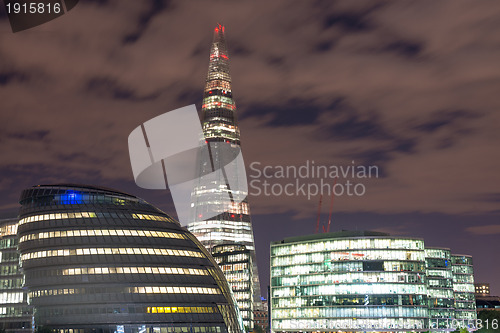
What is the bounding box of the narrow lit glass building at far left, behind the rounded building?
[0,218,32,332]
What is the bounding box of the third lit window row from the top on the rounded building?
[21,247,203,261]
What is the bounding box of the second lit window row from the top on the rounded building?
[19,229,185,242]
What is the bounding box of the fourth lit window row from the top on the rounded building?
[61,267,208,275]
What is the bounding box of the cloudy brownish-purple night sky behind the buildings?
[0,0,500,296]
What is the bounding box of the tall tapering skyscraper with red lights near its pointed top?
[188,24,261,328]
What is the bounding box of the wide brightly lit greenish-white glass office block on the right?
[270,231,475,332]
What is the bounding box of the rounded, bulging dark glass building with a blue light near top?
[18,185,241,333]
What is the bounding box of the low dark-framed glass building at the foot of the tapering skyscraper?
[212,244,253,328]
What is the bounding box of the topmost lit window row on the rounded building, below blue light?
[19,212,173,225]
